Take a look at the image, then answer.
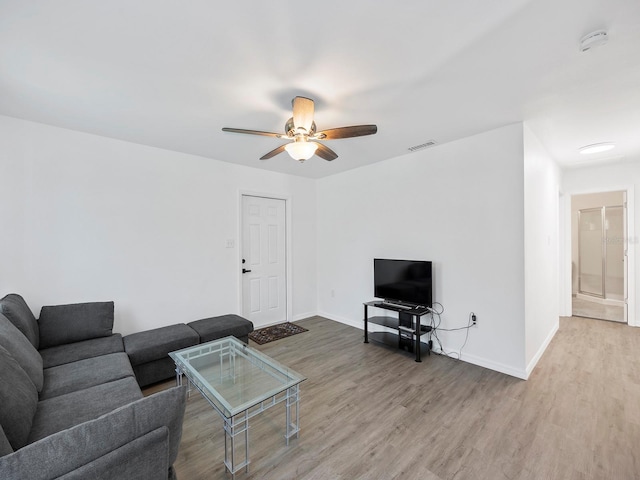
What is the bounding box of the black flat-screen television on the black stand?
[373,258,432,307]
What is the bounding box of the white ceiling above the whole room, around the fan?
[0,0,640,178]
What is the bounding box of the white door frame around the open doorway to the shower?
[560,185,640,327]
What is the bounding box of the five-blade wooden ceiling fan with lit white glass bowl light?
[222,97,378,162]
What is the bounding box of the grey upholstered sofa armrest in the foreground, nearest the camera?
[0,386,186,480]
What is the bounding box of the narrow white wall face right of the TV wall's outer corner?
[524,125,561,374]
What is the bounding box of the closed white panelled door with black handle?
[242,195,287,327]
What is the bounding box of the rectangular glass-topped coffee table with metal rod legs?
[169,337,306,477]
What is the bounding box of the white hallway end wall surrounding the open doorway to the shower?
[562,158,640,326]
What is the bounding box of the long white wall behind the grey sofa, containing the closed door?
[0,117,317,334]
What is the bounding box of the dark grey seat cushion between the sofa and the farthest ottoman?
[123,323,200,367]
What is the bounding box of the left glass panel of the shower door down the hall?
[578,207,605,297]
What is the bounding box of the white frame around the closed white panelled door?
[236,190,293,326]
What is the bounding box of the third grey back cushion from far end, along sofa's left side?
[0,346,38,450]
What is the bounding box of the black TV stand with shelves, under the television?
[364,301,431,362]
